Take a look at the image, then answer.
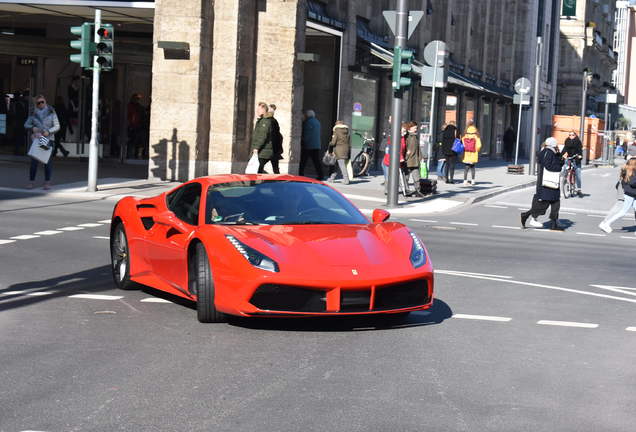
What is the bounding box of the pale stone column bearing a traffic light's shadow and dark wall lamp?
[148,0,214,181]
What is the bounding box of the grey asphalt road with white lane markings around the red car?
[0,167,636,432]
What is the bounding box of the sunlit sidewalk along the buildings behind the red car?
[0,156,535,215]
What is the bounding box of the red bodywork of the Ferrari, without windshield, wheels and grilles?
[113,175,433,316]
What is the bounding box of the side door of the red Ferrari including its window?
[148,182,202,292]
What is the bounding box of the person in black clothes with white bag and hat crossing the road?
[521,137,563,231]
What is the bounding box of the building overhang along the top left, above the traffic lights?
[0,0,155,24]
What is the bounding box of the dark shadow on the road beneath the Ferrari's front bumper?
[229,299,453,332]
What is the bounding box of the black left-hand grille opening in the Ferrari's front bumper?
[250,284,327,312]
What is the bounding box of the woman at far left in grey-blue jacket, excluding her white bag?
[24,95,60,189]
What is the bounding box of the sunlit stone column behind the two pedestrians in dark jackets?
[252,0,304,173]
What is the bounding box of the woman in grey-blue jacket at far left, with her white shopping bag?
[24,95,60,189]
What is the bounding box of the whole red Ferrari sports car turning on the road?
[110,175,433,322]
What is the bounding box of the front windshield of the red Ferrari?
[205,180,369,225]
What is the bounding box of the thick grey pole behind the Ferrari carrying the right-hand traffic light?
[386,0,409,208]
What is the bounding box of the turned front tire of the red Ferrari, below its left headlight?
[190,243,225,323]
